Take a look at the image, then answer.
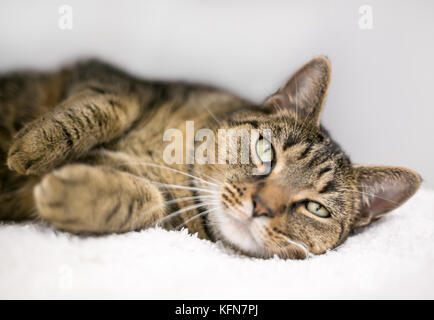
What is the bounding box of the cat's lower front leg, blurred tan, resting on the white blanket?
[34,164,165,233]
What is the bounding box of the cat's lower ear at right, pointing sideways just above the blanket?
[354,166,421,228]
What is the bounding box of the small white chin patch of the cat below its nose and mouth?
[209,204,264,257]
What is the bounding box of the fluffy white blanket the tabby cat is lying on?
[0,189,434,299]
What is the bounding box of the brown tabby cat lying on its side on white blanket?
[0,56,421,259]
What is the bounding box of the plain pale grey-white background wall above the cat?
[0,0,434,187]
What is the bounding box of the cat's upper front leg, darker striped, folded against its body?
[7,91,140,175]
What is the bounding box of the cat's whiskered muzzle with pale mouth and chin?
[197,183,309,259]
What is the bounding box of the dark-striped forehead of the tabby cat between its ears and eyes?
[253,116,351,189]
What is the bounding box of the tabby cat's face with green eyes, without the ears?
[203,115,357,258]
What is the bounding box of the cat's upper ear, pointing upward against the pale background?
[264,56,331,124]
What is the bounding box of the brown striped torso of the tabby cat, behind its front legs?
[0,60,241,237]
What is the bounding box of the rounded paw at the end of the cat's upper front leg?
[7,117,72,175]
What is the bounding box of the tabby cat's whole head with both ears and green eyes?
[197,57,420,259]
